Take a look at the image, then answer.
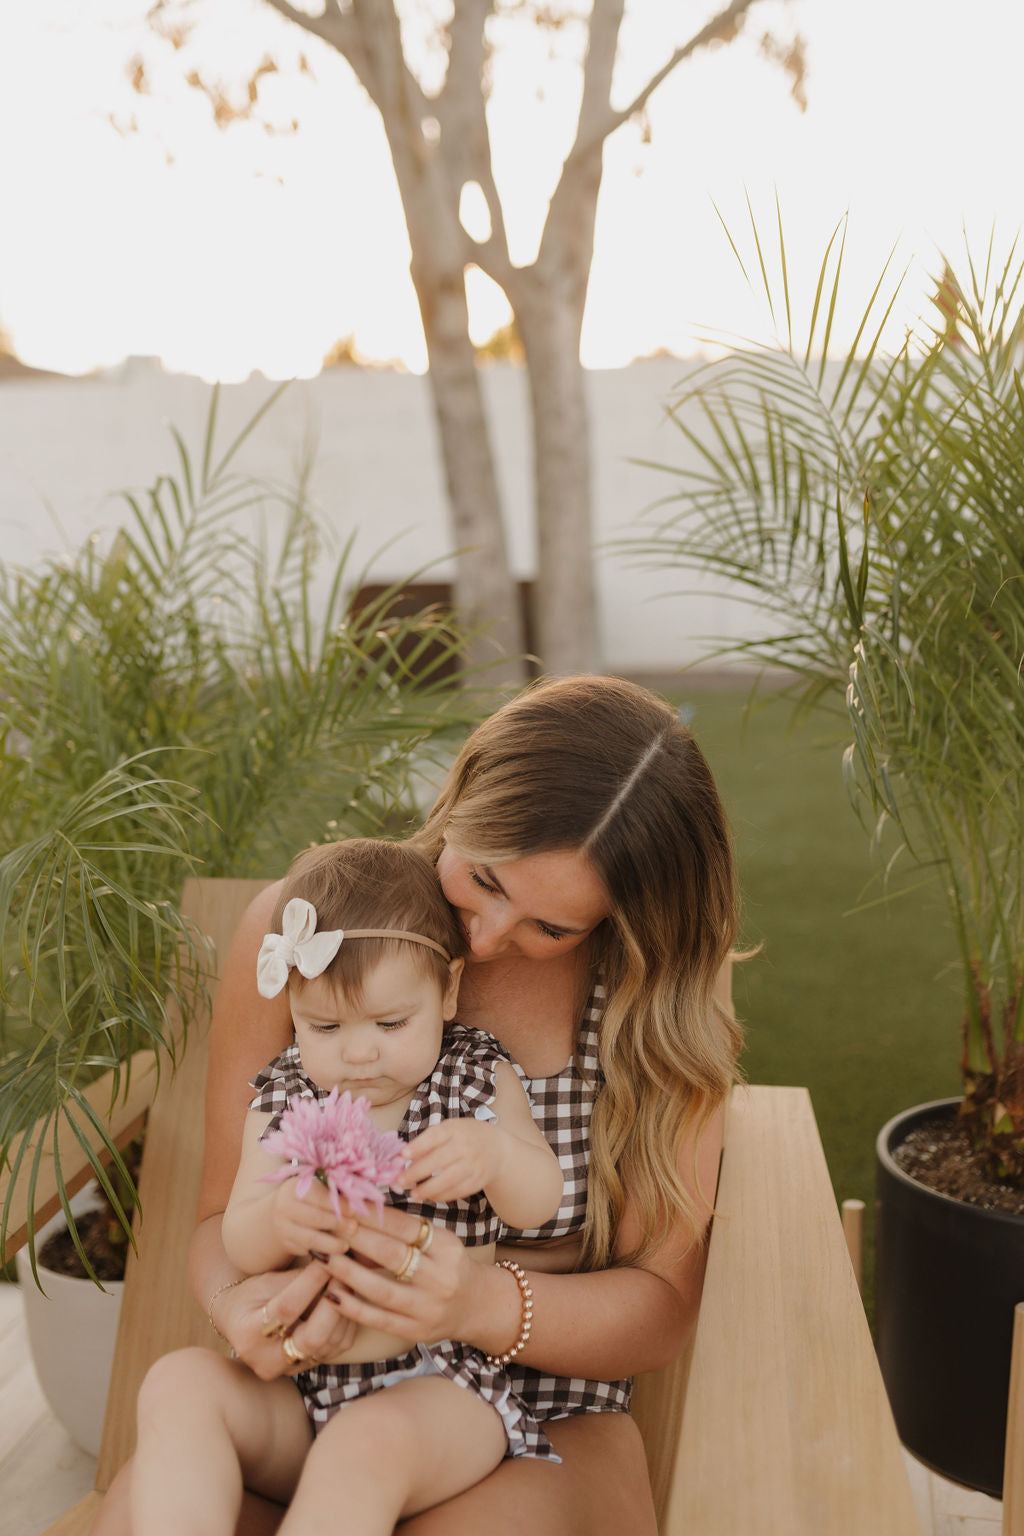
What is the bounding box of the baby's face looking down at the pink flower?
[292,946,462,1109]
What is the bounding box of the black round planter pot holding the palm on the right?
[875,1098,1024,1499]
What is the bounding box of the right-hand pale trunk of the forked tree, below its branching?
[516,284,600,676]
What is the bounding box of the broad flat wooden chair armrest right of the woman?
[663,1087,920,1536]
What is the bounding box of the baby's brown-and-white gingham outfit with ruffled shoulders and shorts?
[249,1025,560,1461]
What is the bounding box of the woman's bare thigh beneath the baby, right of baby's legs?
[399,1413,657,1536]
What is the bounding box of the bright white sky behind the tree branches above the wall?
[0,0,1024,379]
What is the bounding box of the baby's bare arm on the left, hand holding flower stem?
[223,1109,348,1275]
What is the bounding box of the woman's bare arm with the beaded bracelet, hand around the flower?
[329,1112,723,1379]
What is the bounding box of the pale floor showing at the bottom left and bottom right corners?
[0,1284,1001,1536]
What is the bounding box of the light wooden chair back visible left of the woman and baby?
[97,880,266,1488]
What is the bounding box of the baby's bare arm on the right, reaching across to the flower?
[404,1061,562,1229]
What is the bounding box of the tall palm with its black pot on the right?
[628,224,1024,1496]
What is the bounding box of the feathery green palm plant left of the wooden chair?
[0,380,479,1422]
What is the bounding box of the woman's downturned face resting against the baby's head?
[438,845,611,960]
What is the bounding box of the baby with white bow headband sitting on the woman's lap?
[132,839,562,1536]
